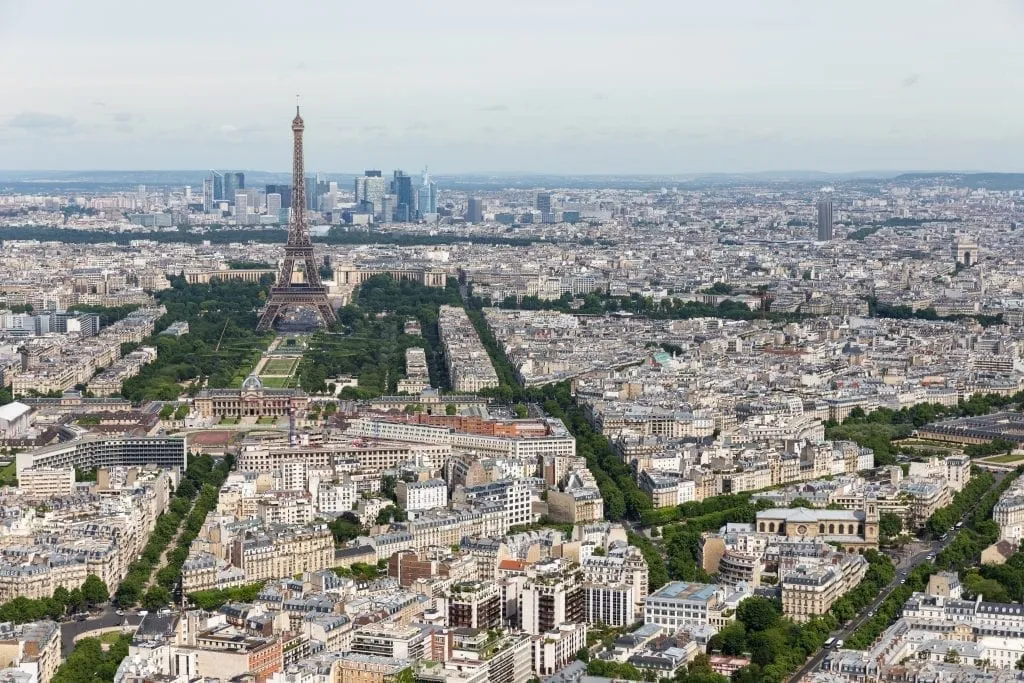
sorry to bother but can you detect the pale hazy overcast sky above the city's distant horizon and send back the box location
[0,0,1024,173]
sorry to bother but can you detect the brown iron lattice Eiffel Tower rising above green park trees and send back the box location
[256,104,337,332]
